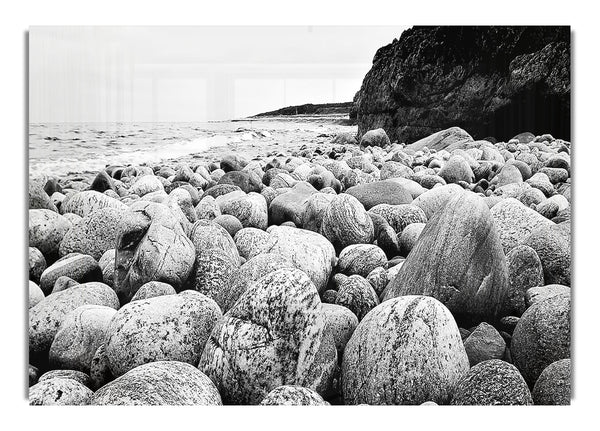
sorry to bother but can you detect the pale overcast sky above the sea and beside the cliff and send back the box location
[29,26,407,123]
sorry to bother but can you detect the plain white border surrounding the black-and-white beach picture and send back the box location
[0,0,600,430]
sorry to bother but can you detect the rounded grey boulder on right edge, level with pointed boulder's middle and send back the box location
[523,222,571,286]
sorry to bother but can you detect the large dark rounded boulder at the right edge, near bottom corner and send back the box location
[510,293,571,385]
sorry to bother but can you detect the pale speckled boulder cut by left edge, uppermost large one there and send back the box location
[29,209,72,257]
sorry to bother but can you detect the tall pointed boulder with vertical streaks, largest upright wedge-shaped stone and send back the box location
[382,192,508,322]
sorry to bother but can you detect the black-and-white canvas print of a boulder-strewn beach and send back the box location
[28,25,573,406]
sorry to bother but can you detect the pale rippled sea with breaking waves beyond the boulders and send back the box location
[29,117,356,177]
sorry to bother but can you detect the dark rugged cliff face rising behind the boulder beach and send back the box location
[354,26,571,143]
